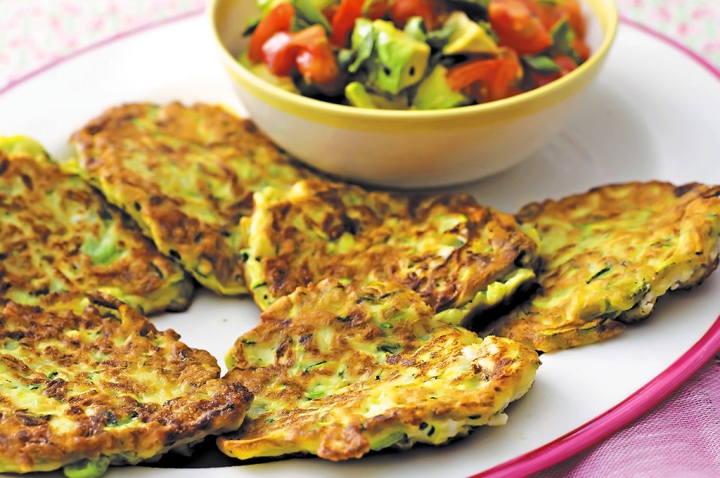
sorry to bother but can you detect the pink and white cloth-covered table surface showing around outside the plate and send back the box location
[0,0,720,478]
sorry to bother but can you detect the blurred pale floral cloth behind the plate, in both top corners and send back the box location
[0,0,720,88]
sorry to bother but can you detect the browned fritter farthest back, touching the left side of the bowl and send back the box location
[69,103,309,295]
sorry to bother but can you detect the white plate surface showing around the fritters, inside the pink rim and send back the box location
[0,16,720,478]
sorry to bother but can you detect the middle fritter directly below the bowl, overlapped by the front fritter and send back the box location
[241,179,537,324]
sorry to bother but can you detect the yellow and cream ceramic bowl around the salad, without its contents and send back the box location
[208,0,618,188]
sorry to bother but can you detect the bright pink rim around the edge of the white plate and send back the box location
[0,9,720,478]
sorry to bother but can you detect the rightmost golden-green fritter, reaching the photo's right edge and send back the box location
[485,182,720,352]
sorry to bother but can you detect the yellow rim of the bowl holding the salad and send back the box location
[206,0,619,130]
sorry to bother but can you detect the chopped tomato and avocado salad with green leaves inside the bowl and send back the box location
[238,0,590,110]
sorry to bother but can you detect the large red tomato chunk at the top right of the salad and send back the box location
[488,0,552,55]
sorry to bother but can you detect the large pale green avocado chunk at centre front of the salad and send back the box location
[368,20,430,95]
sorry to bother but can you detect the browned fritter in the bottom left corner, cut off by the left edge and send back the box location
[0,293,252,478]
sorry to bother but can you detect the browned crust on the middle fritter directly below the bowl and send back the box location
[250,180,537,312]
